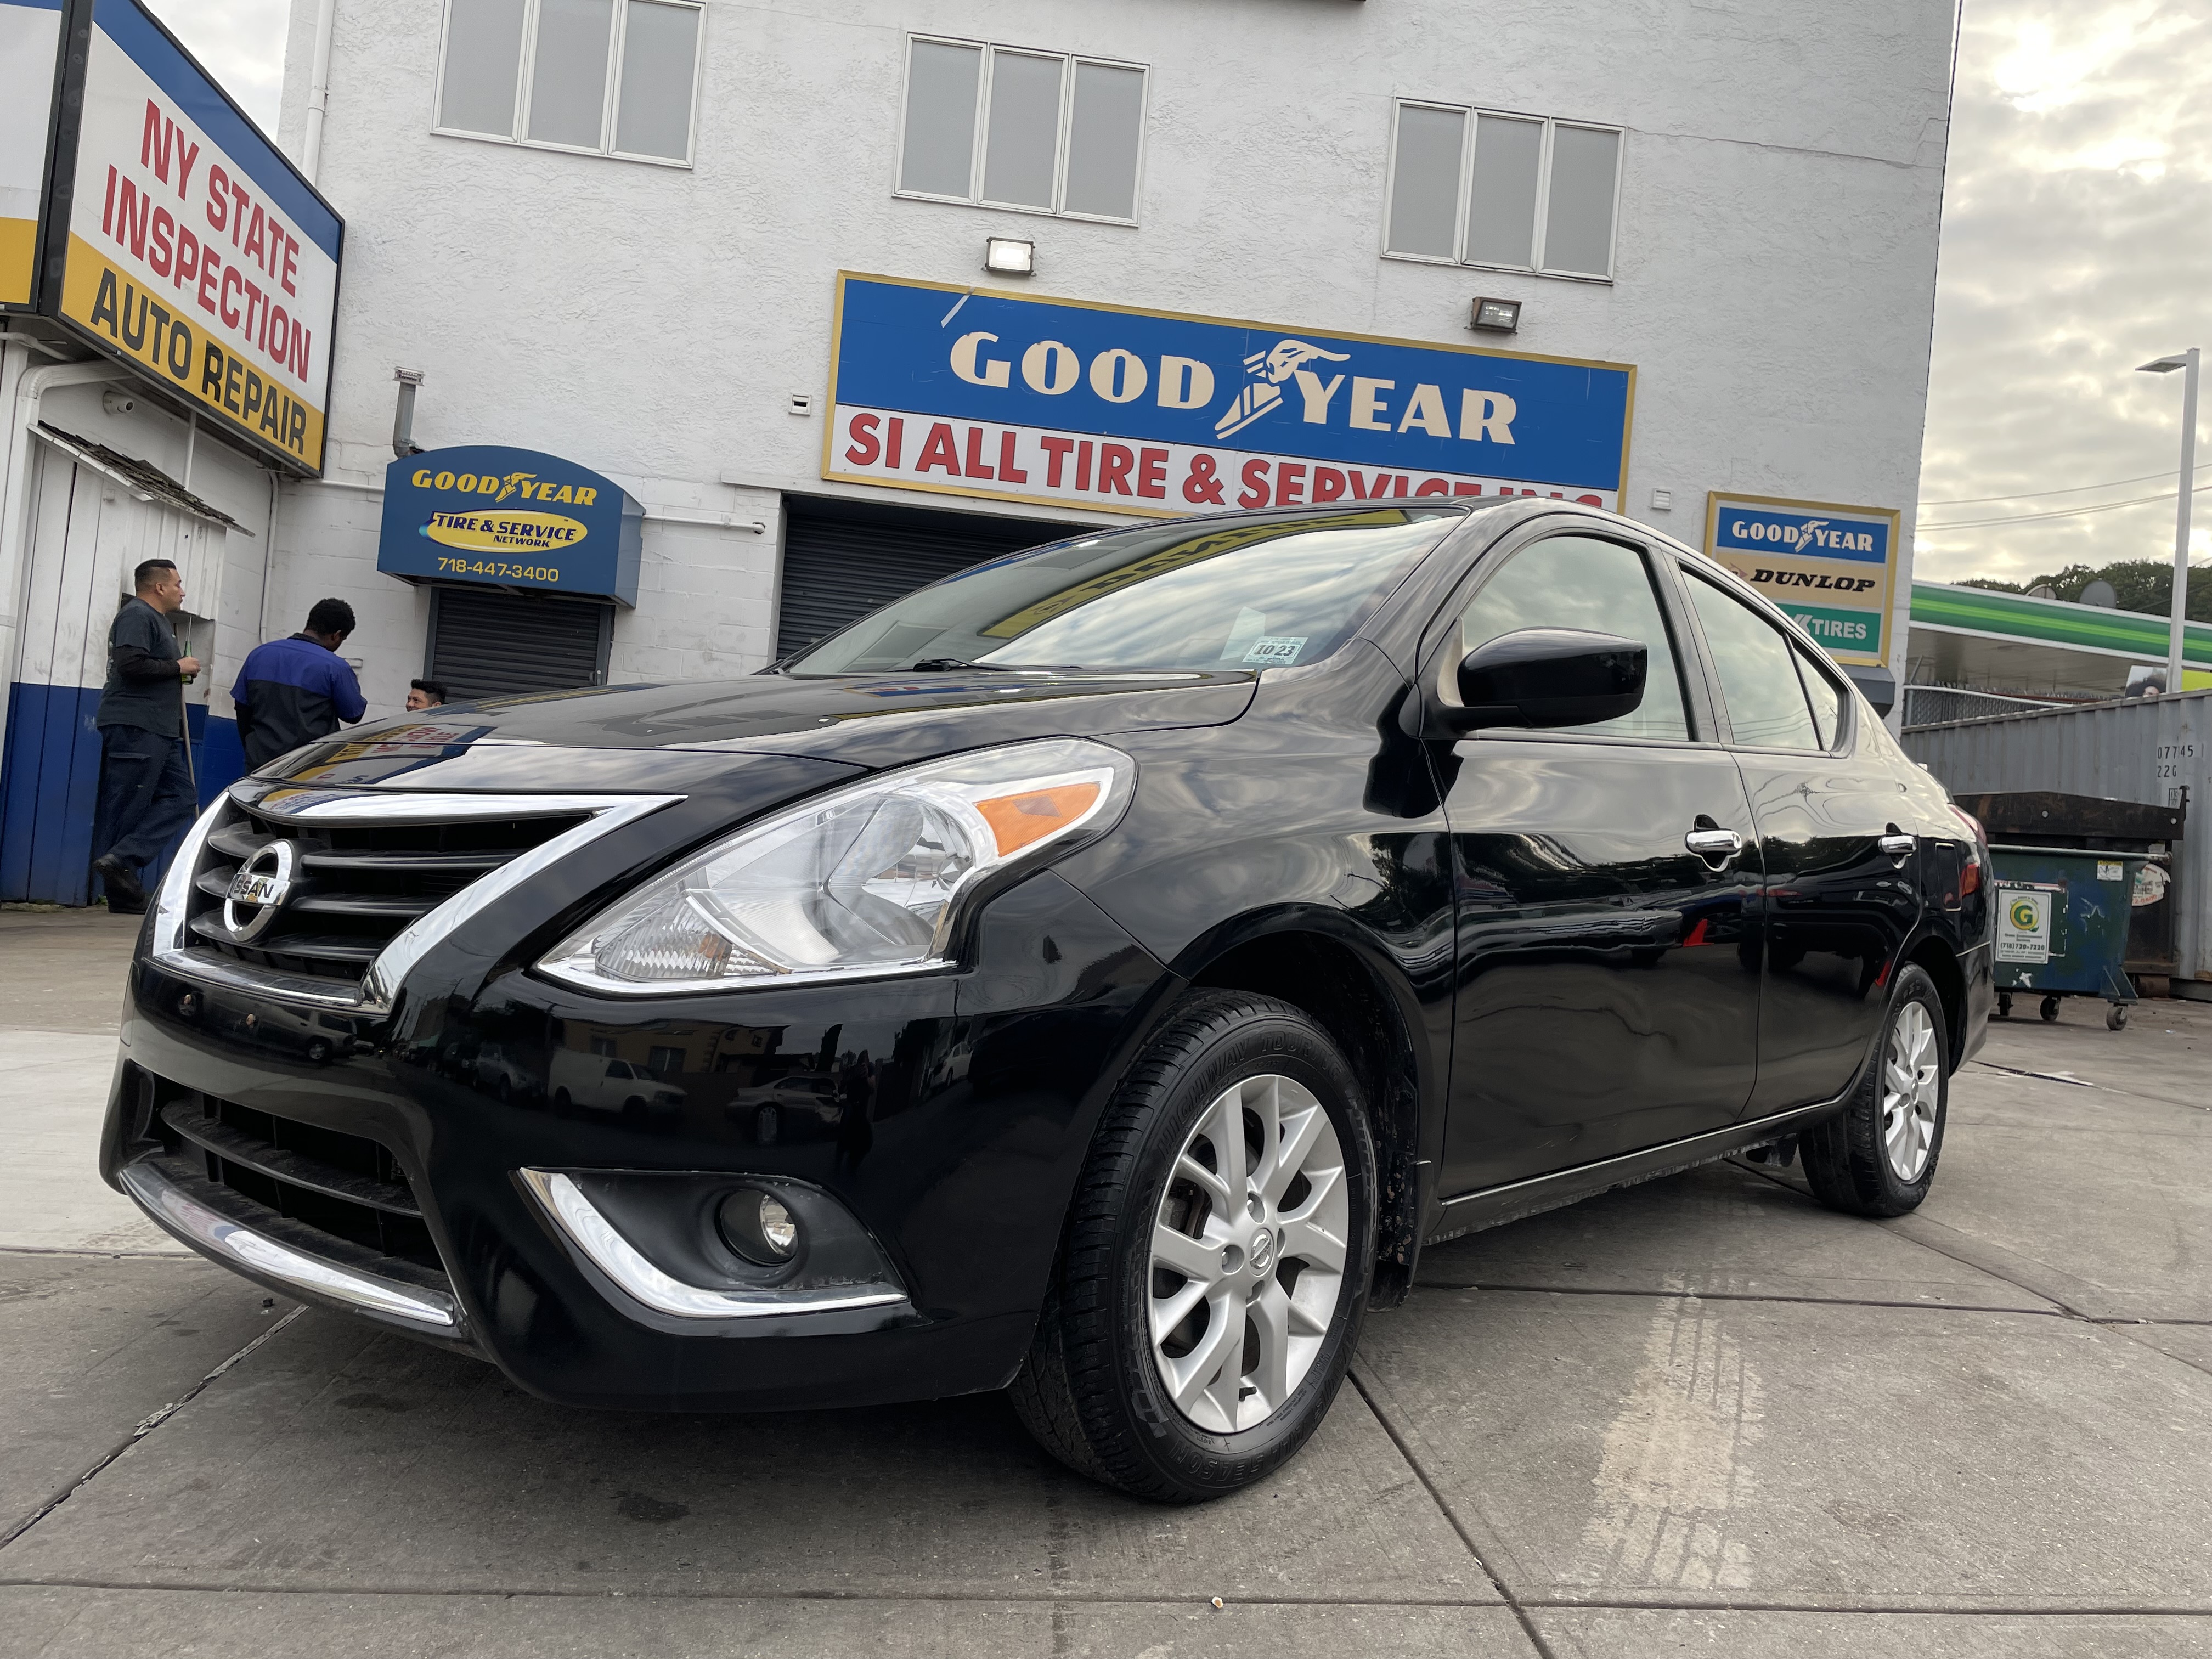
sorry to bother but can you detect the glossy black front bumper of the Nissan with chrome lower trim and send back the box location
[101,870,1177,1411]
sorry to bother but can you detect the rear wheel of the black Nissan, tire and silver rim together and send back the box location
[1798,964,1951,1217]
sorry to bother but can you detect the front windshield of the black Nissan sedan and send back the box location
[785,506,1464,675]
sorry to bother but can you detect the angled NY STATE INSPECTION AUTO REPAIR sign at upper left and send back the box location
[40,0,345,473]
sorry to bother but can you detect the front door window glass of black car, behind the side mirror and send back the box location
[1444,535,1690,743]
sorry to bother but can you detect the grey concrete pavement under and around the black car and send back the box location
[0,911,2212,1659]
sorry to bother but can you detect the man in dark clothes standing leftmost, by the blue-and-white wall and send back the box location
[93,560,199,916]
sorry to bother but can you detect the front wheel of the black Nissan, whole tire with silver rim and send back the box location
[1009,991,1376,1504]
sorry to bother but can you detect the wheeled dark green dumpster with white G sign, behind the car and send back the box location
[1989,845,2150,1031]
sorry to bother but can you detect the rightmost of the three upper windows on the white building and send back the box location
[1383,104,1621,281]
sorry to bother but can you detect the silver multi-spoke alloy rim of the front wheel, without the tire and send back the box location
[1150,1075,1352,1434]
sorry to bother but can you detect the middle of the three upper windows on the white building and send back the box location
[898,36,1146,223]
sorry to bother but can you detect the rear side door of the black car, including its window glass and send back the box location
[1683,571,1920,1117]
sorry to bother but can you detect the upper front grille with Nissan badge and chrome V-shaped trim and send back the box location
[153,778,681,1013]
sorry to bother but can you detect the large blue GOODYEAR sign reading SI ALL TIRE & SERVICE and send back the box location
[823,272,1635,515]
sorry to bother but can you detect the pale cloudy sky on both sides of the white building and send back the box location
[148,0,2212,579]
